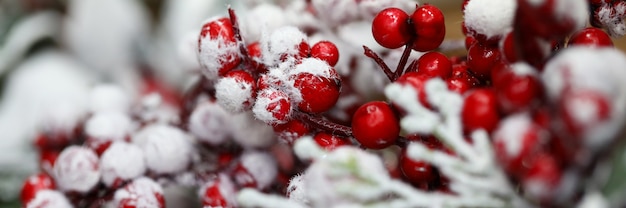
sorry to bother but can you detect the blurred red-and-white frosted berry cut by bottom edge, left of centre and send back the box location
[199,174,237,207]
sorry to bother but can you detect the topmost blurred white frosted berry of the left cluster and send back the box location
[89,84,131,112]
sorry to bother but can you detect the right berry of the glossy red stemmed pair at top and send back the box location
[411,4,446,52]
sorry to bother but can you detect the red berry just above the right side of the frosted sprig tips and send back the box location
[461,88,499,132]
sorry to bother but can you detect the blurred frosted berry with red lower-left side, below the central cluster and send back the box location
[232,151,278,189]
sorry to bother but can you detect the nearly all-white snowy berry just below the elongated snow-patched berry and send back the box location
[215,77,254,113]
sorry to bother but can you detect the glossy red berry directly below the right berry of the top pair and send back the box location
[410,52,452,79]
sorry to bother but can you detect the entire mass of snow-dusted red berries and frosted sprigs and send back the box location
[21,0,626,207]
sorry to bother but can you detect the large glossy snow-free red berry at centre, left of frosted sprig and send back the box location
[352,101,400,149]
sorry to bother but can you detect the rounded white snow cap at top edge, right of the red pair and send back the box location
[464,0,517,38]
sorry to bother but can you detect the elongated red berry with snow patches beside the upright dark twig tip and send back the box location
[198,17,241,80]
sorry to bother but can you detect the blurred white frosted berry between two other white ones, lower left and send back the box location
[100,142,146,187]
